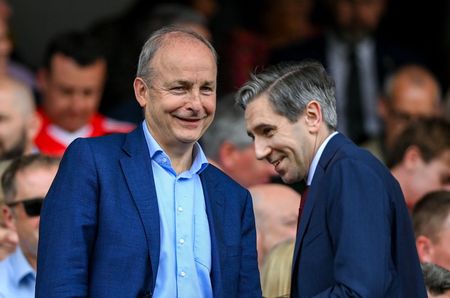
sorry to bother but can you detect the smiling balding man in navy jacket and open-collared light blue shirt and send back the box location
[36,28,261,298]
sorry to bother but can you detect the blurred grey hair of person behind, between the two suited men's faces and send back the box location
[202,94,252,159]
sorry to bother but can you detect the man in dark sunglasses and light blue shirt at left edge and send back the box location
[0,154,59,298]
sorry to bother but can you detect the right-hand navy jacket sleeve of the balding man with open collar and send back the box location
[238,191,262,298]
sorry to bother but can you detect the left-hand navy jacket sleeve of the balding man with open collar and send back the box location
[36,139,98,298]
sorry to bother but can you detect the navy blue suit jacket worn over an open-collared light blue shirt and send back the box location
[36,127,261,298]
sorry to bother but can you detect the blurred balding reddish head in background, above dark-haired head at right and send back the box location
[379,65,441,148]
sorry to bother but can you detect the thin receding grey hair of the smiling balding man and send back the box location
[136,26,217,82]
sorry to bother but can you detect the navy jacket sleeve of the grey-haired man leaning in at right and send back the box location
[315,160,394,298]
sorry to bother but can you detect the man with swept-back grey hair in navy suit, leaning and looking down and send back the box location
[238,62,426,297]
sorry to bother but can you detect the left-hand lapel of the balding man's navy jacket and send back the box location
[120,126,160,286]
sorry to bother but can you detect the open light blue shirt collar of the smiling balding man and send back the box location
[142,120,209,175]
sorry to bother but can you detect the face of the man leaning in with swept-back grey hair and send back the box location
[245,95,313,183]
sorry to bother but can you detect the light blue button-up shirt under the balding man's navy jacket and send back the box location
[142,121,212,298]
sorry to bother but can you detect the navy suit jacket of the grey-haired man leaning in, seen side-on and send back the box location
[291,134,427,298]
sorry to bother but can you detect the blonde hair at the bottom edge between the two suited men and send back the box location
[261,239,295,298]
